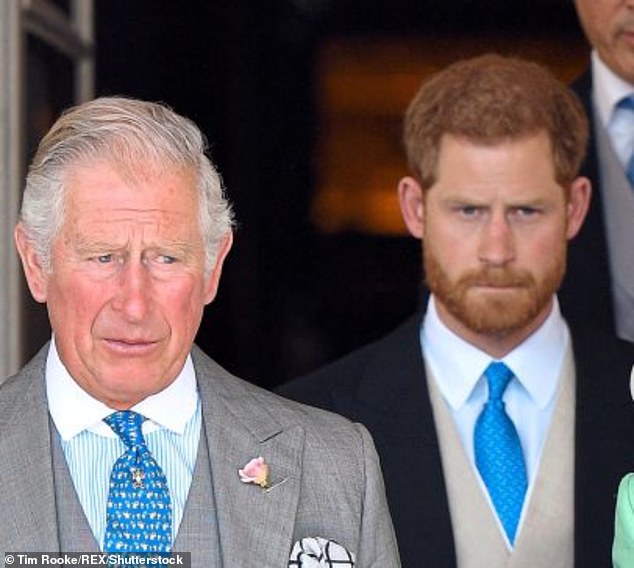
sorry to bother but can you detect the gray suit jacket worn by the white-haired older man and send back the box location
[0,347,400,568]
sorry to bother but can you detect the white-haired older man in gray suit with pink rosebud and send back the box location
[0,98,399,568]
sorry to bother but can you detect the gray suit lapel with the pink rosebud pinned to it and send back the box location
[194,350,304,568]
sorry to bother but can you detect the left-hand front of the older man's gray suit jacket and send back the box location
[0,348,59,551]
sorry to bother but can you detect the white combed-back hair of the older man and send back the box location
[20,97,233,272]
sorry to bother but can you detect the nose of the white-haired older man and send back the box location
[113,260,152,323]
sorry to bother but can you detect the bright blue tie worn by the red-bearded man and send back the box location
[473,363,527,544]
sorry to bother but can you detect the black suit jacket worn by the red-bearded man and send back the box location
[279,317,634,568]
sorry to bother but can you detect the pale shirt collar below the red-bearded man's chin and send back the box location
[421,295,570,409]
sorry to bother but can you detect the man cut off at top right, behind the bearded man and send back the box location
[561,0,634,343]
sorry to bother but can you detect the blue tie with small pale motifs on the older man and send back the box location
[104,410,172,553]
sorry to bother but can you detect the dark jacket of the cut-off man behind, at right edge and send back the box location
[559,70,614,333]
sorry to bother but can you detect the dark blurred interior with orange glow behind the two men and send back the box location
[0,0,589,387]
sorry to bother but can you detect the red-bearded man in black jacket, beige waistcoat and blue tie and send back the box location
[280,55,634,568]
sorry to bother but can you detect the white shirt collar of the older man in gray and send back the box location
[46,337,198,440]
